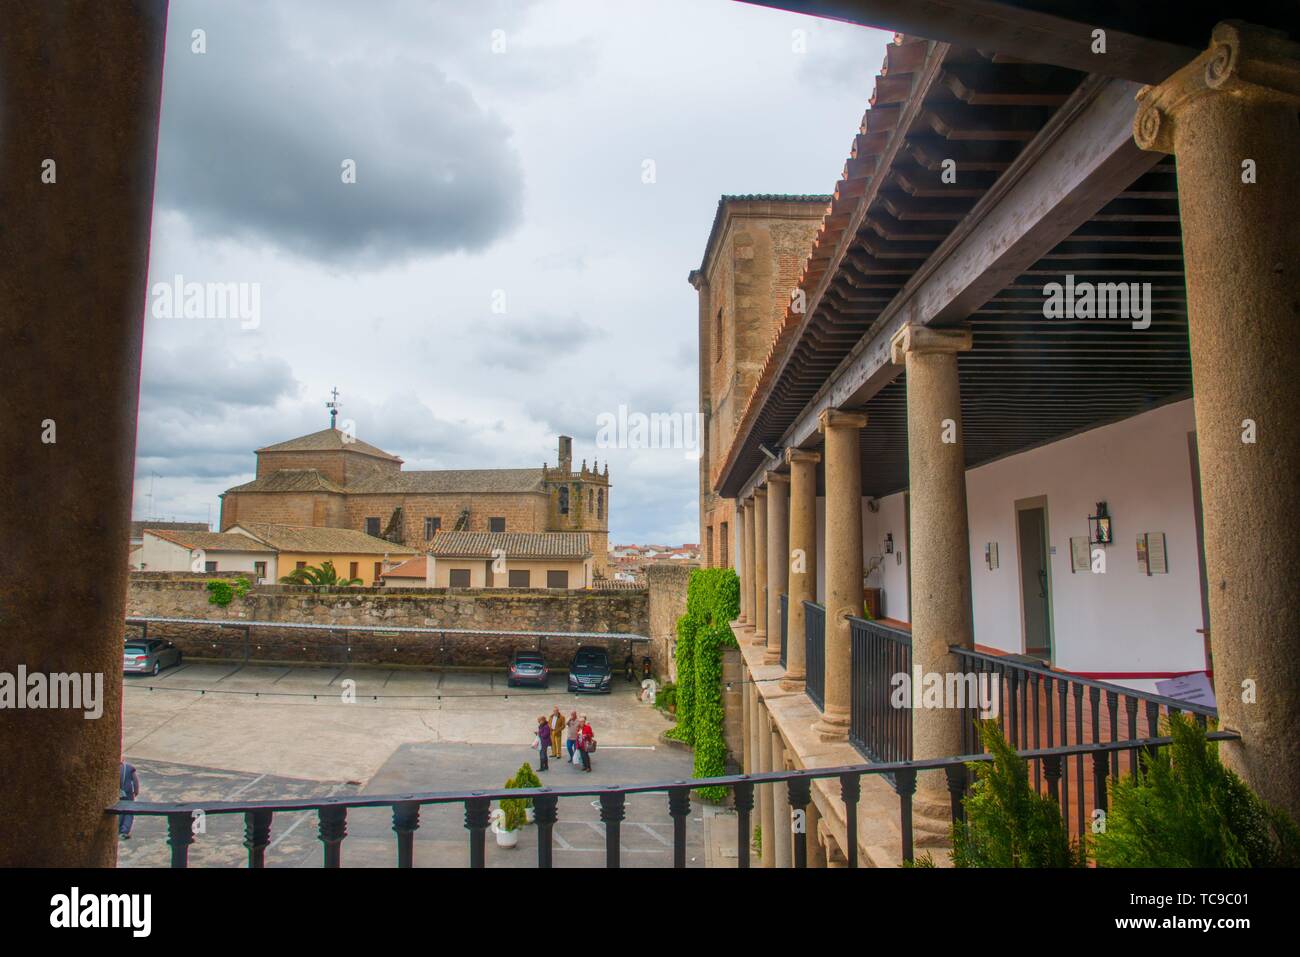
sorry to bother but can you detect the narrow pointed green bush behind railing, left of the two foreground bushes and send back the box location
[952,720,1087,867]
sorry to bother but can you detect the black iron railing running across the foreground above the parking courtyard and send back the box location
[107,731,1238,869]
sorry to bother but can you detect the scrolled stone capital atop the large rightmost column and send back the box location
[1134,20,1300,153]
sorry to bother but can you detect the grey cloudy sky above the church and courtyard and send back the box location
[134,0,888,544]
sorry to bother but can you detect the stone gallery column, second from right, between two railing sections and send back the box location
[889,325,972,817]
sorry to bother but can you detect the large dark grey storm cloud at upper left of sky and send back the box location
[157,0,523,268]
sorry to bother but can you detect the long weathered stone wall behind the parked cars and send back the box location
[126,572,649,671]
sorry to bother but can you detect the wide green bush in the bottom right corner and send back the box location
[1093,715,1300,867]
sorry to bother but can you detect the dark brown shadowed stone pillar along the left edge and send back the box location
[0,0,166,867]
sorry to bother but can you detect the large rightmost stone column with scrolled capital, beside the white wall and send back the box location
[1132,23,1300,818]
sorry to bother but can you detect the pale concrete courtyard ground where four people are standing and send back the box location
[120,662,735,867]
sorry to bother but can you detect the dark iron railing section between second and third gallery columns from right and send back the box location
[849,618,909,761]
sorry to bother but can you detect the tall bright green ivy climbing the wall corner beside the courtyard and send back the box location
[667,568,740,801]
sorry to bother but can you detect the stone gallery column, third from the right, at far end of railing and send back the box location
[813,408,867,741]
